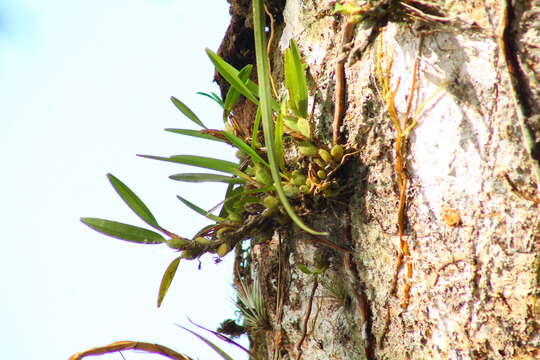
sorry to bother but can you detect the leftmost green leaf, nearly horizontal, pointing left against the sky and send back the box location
[81,218,165,244]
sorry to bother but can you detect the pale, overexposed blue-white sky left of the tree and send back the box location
[0,0,251,360]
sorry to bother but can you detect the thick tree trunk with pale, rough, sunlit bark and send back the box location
[222,0,540,360]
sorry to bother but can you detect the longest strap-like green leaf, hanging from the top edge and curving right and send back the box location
[253,0,328,235]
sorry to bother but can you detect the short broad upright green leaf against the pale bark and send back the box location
[285,39,308,118]
